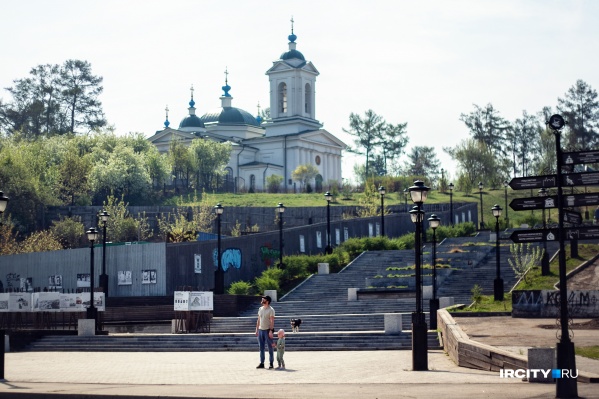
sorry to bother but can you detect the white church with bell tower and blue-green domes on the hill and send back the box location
[148,26,346,192]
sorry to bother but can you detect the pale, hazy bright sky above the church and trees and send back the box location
[0,0,599,183]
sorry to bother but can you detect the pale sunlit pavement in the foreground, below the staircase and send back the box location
[0,350,599,399]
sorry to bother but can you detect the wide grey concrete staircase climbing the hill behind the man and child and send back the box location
[27,233,551,352]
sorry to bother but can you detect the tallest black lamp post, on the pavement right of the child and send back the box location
[408,180,429,371]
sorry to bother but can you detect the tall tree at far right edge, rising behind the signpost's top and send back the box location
[557,79,599,151]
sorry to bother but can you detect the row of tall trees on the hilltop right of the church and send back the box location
[344,80,599,193]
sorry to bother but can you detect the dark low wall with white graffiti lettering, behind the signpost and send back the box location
[512,290,599,317]
